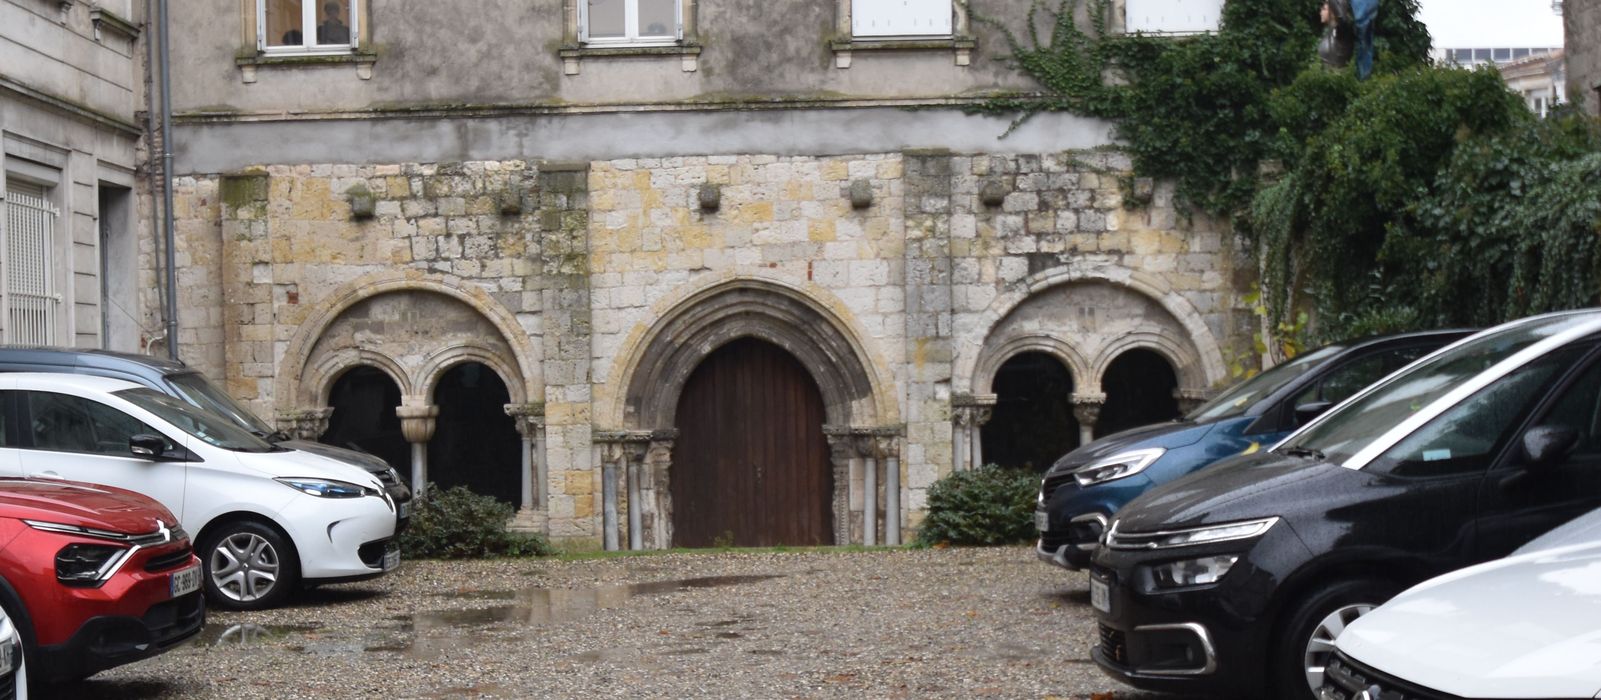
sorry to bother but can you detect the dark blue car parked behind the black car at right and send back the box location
[1034,330,1471,569]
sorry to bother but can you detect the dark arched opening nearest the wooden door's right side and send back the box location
[981,352,1079,471]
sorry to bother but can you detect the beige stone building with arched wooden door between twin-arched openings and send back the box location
[139,0,1254,548]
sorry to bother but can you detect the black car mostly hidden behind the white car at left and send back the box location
[0,346,411,527]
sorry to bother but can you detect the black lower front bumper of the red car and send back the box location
[29,591,205,681]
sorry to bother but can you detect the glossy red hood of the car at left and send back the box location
[0,479,178,535]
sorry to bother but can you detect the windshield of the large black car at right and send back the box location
[1279,314,1596,465]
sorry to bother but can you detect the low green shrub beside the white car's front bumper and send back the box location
[400,484,554,559]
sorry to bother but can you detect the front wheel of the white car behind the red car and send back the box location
[197,521,299,610]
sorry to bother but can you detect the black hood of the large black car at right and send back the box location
[1117,452,1338,532]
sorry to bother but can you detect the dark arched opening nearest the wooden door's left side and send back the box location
[427,362,522,505]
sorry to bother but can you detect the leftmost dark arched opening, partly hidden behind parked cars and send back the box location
[317,365,411,479]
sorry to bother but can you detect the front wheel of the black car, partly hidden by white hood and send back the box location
[1268,578,1396,700]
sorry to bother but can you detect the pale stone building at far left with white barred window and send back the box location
[0,0,146,351]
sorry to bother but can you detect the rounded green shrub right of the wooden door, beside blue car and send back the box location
[917,465,1039,545]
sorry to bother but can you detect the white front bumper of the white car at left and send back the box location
[279,495,399,583]
